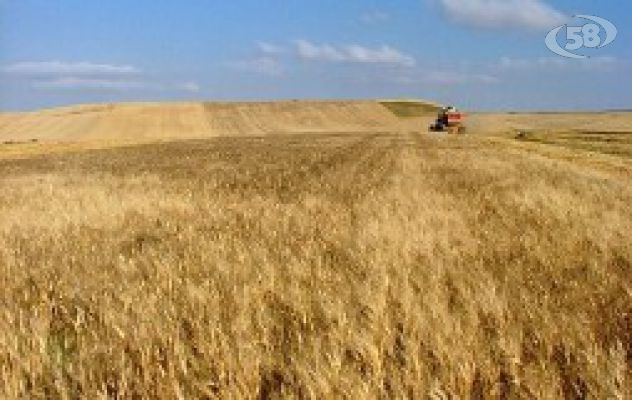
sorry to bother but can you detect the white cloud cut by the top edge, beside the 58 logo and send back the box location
[438,0,566,31]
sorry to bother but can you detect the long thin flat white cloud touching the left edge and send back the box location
[2,61,141,76]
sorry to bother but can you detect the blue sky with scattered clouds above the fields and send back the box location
[0,0,632,111]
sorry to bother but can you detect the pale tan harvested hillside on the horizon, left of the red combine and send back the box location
[0,101,434,142]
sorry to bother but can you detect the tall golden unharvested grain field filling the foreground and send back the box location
[0,128,632,399]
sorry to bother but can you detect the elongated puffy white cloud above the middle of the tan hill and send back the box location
[295,40,415,67]
